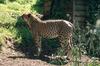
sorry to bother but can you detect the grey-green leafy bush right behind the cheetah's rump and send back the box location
[73,23,100,57]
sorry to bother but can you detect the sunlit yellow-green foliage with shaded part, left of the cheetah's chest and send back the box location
[0,0,43,50]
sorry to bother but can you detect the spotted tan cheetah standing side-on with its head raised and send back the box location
[22,13,73,59]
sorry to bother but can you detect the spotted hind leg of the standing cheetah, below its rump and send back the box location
[59,36,72,61]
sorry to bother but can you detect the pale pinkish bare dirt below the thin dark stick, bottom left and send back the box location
[0,53,55,66]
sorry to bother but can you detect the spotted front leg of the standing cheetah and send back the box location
[34,35,41,56]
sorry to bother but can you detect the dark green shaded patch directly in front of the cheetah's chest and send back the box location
[15,17,34,56]
